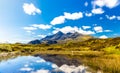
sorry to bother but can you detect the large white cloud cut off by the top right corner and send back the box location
[92,0,120,8]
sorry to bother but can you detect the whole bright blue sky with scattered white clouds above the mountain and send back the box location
[0,0,120,43]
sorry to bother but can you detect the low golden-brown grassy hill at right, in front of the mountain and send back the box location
[64,37,120,53]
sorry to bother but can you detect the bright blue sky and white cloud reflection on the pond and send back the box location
[0,56,87,73]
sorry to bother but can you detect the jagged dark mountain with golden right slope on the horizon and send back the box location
[29,31,93,44]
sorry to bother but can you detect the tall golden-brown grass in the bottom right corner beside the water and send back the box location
[84,55,120,73]
